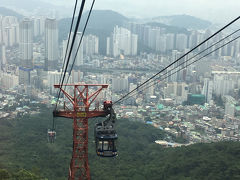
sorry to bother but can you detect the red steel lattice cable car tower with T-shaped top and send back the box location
[53,84,108,180]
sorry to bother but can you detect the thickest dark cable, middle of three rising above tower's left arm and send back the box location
[56,0,85,108]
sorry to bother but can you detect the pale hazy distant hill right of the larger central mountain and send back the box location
[152,15,211,29]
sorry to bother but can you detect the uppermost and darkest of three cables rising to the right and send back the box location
[113,16,240,105]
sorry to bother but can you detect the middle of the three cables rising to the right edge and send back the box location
[114,29,240,102]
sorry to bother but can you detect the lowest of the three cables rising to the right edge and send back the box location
[116,36,240,102]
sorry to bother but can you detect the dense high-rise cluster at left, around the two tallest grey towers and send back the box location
[0,16,99,95]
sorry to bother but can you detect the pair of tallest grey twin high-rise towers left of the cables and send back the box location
[19,18,59,85]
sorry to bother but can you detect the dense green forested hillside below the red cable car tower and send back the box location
[0,105,240,180]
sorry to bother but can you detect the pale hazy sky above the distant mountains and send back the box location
[42,0,240,22]
